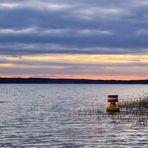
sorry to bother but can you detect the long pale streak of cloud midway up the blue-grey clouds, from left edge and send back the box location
[0,27,113,35]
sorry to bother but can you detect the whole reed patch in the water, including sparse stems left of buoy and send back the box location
[75,96,148,127]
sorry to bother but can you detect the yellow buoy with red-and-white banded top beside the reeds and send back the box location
[106,95,120,112]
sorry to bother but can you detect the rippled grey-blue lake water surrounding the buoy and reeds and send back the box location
[0,84,148,148]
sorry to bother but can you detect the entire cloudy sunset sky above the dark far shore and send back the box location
[0,0,148,80]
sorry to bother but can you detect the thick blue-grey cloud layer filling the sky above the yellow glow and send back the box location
[0,0,148,55]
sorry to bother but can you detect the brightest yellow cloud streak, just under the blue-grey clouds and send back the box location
[23,54,148,64]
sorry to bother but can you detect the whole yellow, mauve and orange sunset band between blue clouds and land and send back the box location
[0,54,148,80]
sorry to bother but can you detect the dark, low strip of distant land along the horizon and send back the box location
[0,78,148,84]
